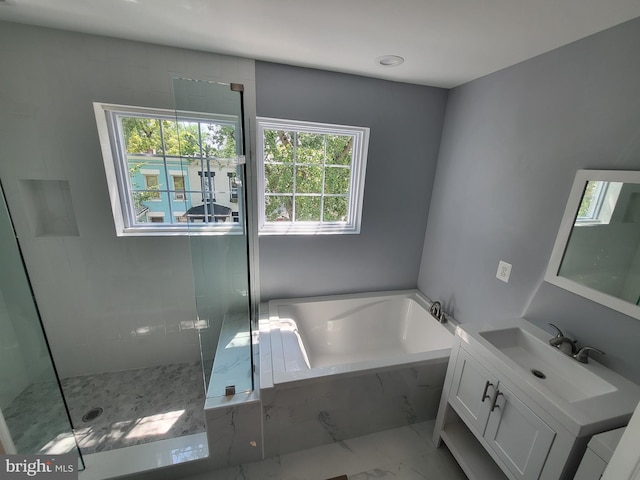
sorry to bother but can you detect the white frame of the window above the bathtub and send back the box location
[256,117,369,235]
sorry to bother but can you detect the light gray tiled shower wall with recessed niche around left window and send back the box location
[0,23,255,377]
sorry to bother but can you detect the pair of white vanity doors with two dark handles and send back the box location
[448,348,556,480]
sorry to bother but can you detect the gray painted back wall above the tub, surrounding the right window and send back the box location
[256,62,447,300]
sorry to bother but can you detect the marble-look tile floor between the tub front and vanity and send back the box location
[182,420,467,480]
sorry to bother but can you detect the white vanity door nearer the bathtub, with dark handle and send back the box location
[449,348,498,436]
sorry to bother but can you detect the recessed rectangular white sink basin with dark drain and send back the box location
[479,327,616,402]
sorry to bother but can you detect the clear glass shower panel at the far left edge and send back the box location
[0,186,83,468]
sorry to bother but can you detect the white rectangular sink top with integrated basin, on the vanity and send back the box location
[456,318,640,437]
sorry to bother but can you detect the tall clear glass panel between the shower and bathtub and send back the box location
[173,78,253,397]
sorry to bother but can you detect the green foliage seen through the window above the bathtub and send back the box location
[264,130,353,222]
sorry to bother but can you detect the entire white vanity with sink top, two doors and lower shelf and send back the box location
[433,318,640,480]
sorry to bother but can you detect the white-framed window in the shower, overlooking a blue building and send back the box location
[94,103,242,235]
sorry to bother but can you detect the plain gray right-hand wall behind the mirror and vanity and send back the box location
[418,15,640,382]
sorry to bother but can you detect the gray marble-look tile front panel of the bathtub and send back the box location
[260,358,447,456]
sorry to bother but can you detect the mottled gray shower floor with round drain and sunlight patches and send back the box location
[7,362,205,455]
